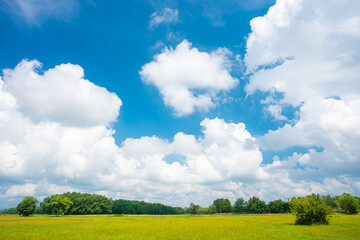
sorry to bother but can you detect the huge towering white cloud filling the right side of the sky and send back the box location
[244,0,360,188]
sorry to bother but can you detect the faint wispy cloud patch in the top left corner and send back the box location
[0,0,79,26]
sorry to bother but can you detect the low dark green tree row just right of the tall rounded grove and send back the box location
[112,199,184,215]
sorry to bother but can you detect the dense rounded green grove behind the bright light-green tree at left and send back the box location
[41,192,113,215]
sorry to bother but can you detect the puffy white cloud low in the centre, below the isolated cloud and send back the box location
[118,118,267,183]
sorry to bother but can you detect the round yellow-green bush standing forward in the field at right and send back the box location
[290,194,332,225]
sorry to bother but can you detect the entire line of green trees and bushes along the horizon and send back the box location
[0,192,360,224]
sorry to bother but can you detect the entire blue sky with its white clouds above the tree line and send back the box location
[0,0,360,208]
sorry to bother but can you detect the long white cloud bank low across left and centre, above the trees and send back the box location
[0,113,268,205]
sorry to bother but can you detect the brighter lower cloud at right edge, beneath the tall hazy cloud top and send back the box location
[259,96,360,177]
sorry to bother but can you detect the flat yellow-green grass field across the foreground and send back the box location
[0,214,360,240]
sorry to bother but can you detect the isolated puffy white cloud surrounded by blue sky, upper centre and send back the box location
[140,40,238,116]
